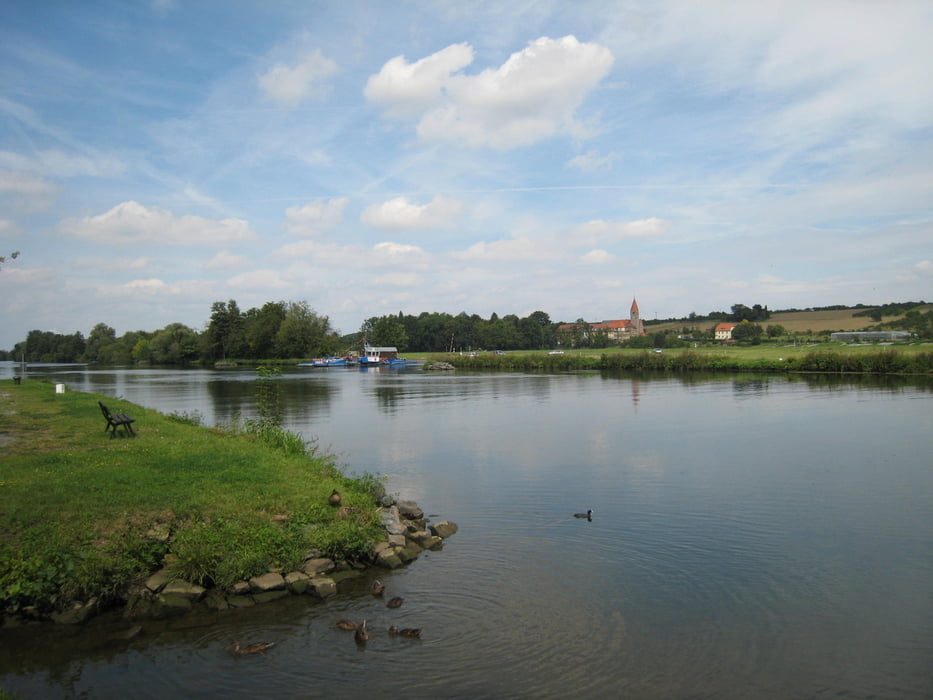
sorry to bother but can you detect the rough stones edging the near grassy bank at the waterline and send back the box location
[13,501,457,625]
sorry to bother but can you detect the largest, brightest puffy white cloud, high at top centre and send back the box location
[365,36,613,150]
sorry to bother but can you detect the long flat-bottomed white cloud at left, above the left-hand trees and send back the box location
[59,201,254,245]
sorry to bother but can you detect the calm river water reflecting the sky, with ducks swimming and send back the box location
[0,365,933,698]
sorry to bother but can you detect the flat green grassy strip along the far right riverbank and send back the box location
[431,344,933,374]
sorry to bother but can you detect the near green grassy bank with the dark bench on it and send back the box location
[0,379,380,612]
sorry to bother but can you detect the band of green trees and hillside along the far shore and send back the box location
[0,299,933,366]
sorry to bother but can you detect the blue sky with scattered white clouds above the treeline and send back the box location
[0,0,933,349]
